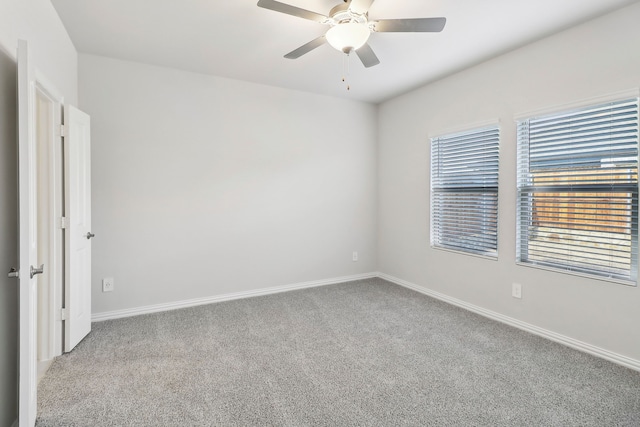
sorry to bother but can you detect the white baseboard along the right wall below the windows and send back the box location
[378,273,640,371]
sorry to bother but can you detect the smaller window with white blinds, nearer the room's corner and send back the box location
[431,126,500,257]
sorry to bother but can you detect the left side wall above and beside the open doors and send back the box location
[0,0,77,426]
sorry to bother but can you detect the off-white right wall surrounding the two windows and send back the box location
[378,4,640,360]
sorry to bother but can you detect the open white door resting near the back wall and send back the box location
[64,106,93,351]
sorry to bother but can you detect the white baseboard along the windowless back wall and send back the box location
[91,273,378,322]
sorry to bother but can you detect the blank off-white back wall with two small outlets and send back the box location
[79,55,377,314]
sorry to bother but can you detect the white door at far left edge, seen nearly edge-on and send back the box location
[18,40,42,427]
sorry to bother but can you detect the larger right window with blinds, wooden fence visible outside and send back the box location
[516,99,638,282]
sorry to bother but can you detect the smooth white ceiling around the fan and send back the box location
[52,0,638,103]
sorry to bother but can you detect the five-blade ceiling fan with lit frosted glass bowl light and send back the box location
[258,0,447,68]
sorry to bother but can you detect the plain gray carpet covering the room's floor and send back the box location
[37,279,640,427]
